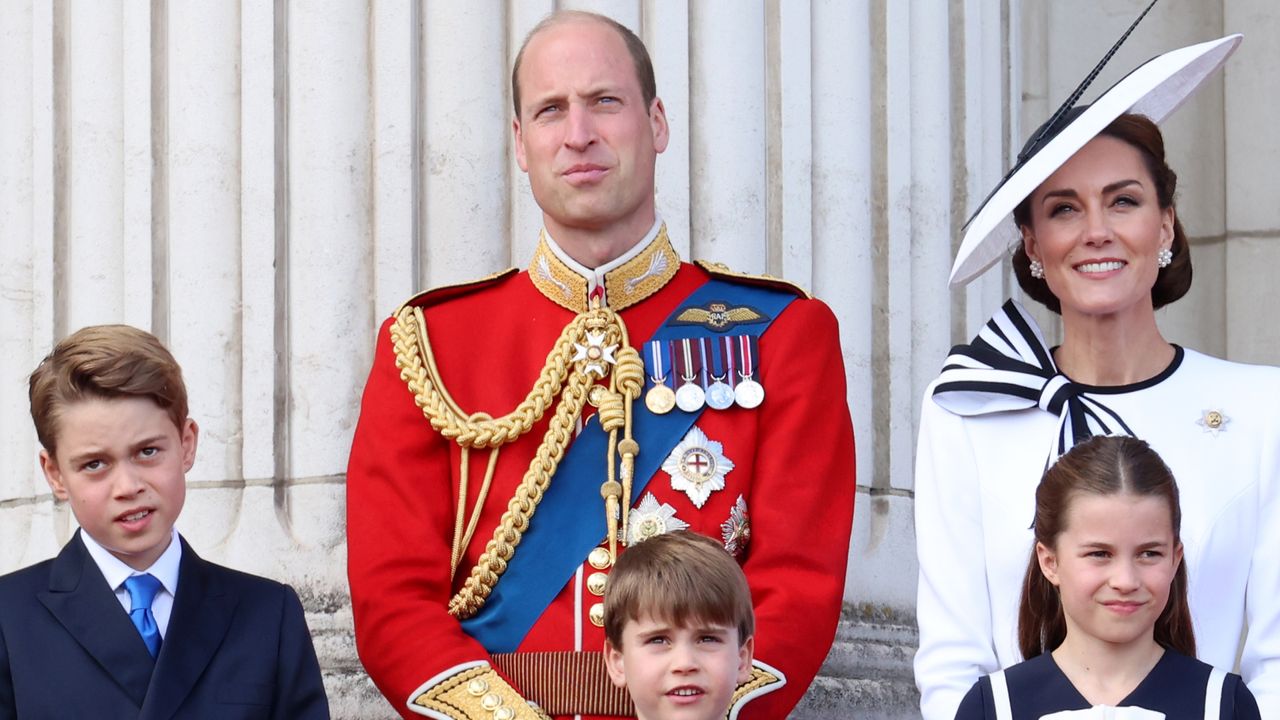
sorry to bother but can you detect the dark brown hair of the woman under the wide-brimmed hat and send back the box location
[1014,113,1192,313]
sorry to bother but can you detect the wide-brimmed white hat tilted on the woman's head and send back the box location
[950,32,1244,288]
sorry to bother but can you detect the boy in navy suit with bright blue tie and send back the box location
[0,325,329,720]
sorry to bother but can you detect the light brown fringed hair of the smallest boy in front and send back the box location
[604,530,755,648]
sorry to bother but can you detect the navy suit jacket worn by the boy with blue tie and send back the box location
[0,532,329,720]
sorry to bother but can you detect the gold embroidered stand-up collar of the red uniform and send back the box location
[529,223,680,313]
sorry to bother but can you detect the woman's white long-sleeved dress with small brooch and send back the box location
[915,301,1280,720]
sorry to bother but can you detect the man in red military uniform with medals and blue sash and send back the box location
[347,12,855,720]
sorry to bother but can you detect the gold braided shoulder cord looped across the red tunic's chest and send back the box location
[390,298,644,619]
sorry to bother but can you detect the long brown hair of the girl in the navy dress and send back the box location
[1018,436,1196,660]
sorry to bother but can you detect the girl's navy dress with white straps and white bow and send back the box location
[955,651,1262,720]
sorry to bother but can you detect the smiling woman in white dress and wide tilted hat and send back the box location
[915,30,1280,720]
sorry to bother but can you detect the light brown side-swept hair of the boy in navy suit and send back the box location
[28,325,187,455]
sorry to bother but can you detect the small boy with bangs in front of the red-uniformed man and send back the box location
[604,530,781,720]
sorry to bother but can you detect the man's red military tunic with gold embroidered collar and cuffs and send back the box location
[347,225,855,719]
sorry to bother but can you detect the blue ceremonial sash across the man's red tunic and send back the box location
[462,279,796,653]
